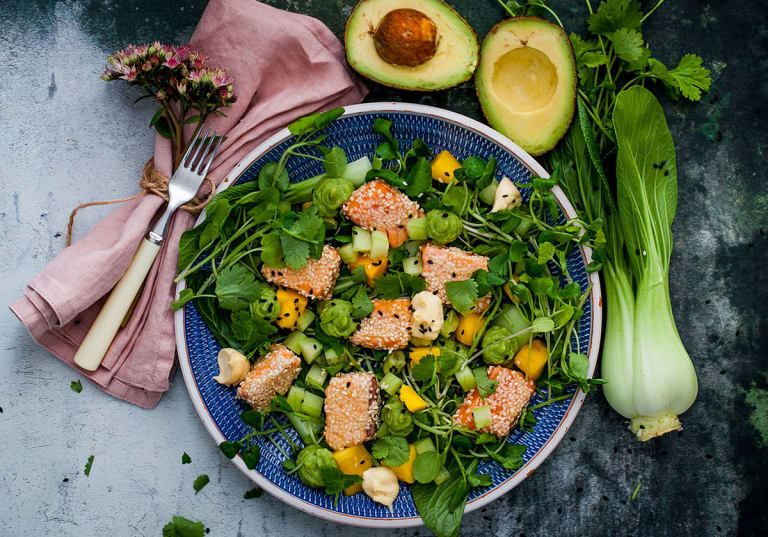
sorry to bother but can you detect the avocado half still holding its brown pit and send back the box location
[344,0,479,91]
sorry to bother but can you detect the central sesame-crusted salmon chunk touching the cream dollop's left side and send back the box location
[349,298,411,351]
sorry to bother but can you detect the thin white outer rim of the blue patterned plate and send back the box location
[174,102,603,528]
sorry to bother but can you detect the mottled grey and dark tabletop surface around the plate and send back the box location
[0,0,768,537]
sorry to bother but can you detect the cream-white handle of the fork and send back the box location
[75,239,160,371]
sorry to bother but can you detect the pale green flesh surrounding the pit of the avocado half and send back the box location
[344,0,479,91]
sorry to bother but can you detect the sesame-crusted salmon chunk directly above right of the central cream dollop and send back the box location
[421,243,491,312]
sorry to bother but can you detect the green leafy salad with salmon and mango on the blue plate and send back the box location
[173,105,601,536]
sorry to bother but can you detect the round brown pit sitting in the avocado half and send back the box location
[373,8,437,67]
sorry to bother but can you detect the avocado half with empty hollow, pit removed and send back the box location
[475,17,576,155]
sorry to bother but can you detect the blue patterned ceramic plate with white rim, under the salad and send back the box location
[175,103,602,528]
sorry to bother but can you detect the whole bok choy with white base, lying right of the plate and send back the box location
[602,86,698,440]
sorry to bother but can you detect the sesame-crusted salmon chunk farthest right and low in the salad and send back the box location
[453,365,536,437]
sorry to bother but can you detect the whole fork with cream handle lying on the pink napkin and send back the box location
[75,128,223,371]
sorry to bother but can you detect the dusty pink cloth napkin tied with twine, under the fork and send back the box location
[10,0,366,408]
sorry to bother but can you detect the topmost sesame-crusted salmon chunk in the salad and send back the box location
[341,179,424,248]
